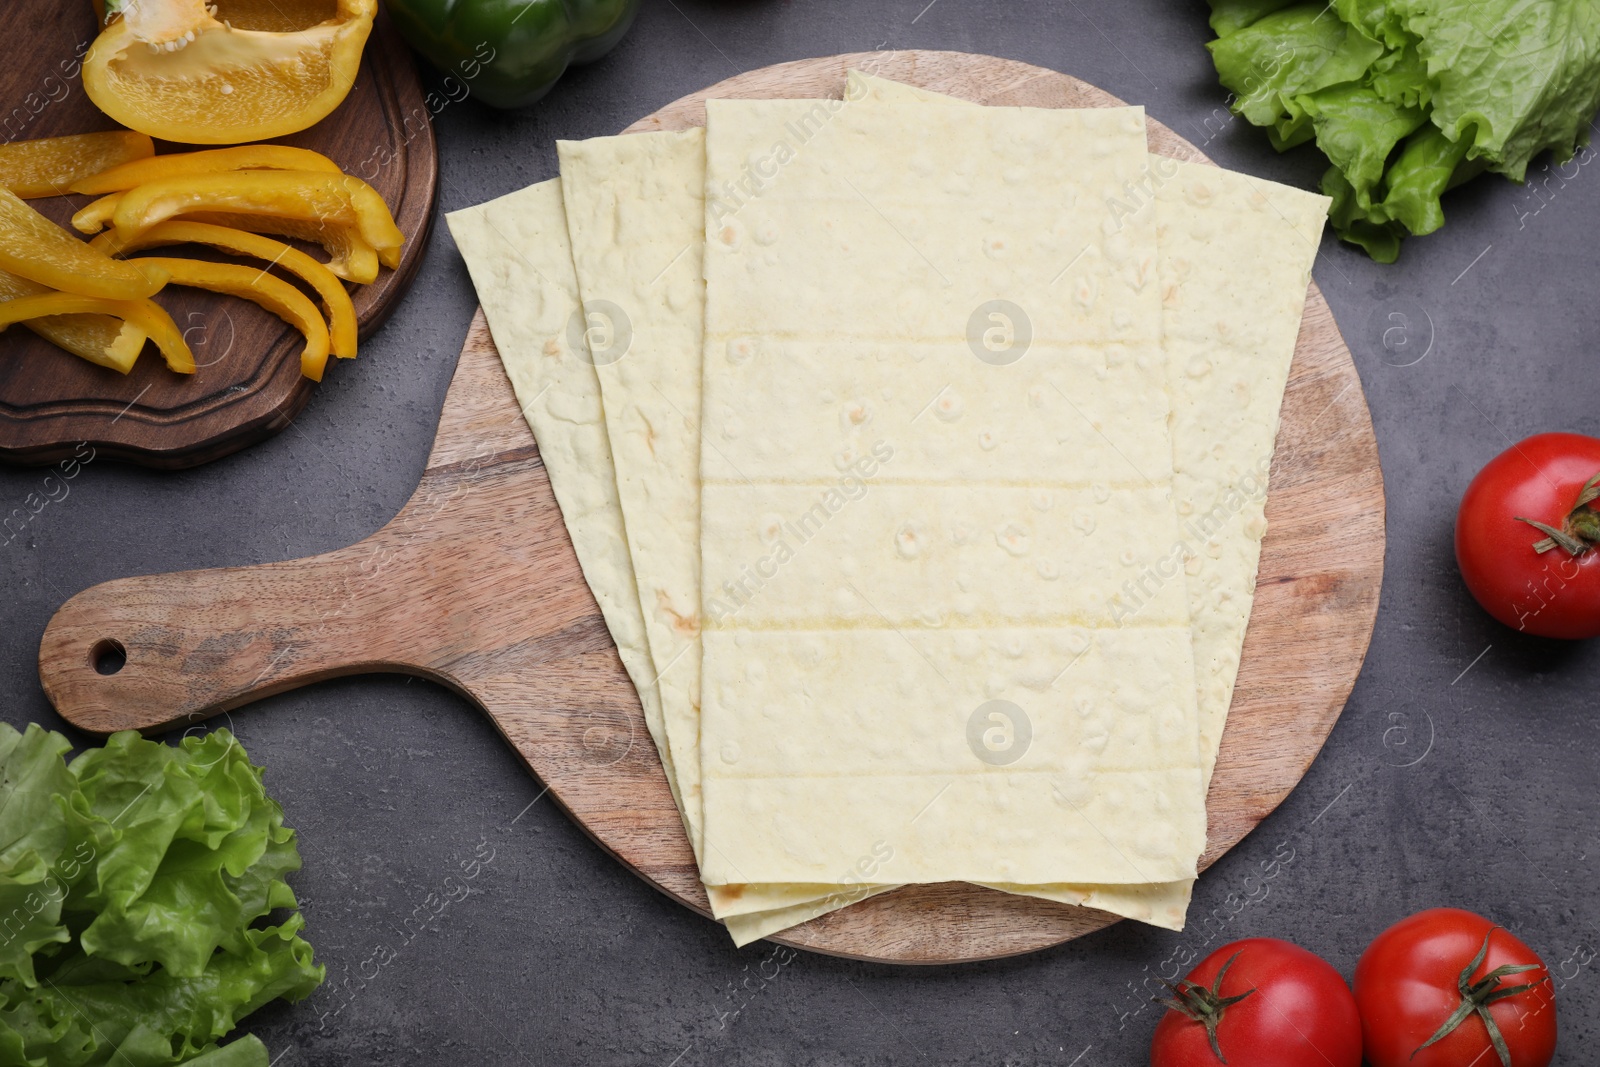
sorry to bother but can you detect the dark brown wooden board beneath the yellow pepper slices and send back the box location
[0,0,438,469]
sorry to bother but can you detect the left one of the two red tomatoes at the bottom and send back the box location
[1150,937,1362,1067]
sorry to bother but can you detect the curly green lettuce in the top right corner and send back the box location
[1208,0,1600,255]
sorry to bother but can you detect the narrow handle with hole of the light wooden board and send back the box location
[38,541,432,733]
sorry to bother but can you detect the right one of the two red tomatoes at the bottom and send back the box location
[1355,907,1555,1067]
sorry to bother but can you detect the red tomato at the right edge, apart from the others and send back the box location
[1456,434,1600,638]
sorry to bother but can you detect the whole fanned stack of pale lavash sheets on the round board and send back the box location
[450,74,1328,944]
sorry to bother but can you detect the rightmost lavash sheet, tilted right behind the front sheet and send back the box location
[846,70,1328,928]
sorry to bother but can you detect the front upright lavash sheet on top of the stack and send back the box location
[701,101,1205,885]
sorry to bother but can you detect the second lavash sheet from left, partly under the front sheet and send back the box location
[555,130,706,857]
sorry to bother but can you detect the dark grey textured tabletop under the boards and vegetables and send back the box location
[0,0,1600,1067]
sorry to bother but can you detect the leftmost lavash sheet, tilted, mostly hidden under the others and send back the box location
[446,179,683,811]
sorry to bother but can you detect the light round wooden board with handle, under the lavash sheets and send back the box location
[40,53,1384,963]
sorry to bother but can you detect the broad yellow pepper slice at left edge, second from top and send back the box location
[0,189,166,301]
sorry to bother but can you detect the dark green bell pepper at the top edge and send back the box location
[386,0,638,107]
